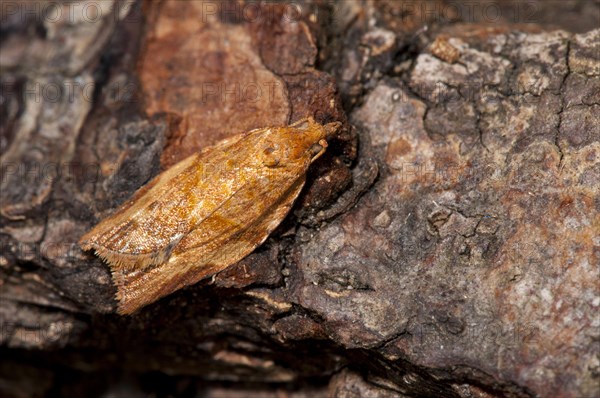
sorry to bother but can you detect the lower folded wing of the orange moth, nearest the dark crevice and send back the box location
[113,174,304,314]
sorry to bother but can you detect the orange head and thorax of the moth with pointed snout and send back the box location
[261,118,341,167]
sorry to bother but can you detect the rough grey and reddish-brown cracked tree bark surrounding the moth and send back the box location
[0,1,600,397]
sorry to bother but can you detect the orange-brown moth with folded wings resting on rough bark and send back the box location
[79,117,340,314]
